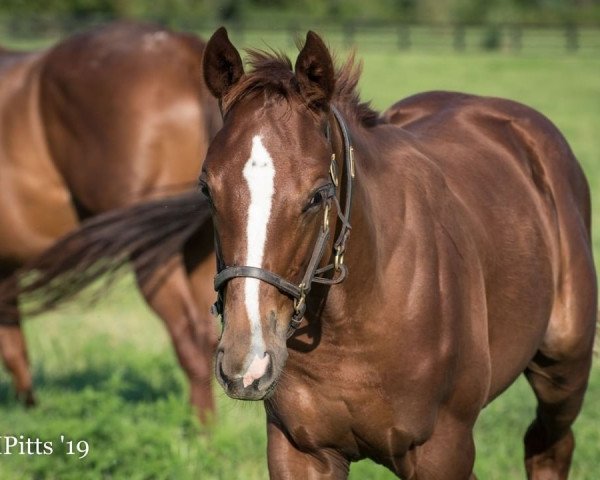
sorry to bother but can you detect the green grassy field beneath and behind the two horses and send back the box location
[0,43,600,480]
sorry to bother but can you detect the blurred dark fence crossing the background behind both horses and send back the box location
[0,17,600,55]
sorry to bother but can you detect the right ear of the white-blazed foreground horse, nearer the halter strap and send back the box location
[295,31,335,106]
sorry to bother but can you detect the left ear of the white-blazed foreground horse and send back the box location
[203,27,244,99]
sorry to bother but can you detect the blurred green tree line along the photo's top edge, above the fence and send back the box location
[0,0,600,24]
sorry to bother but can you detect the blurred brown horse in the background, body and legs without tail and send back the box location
[0,23,221,420]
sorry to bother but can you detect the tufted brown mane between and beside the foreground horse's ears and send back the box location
[222,45,379,127]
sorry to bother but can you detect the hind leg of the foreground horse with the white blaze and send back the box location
[525,256,596,480]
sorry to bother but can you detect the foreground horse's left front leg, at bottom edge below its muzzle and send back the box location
[267,421,350,480]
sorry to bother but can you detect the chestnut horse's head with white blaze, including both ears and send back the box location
[201,29,342,400]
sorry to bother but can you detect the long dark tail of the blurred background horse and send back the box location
[0,192,211,315]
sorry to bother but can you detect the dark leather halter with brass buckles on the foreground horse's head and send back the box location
[213,105,355,338]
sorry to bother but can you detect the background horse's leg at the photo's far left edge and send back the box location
[0,272,35,406]
